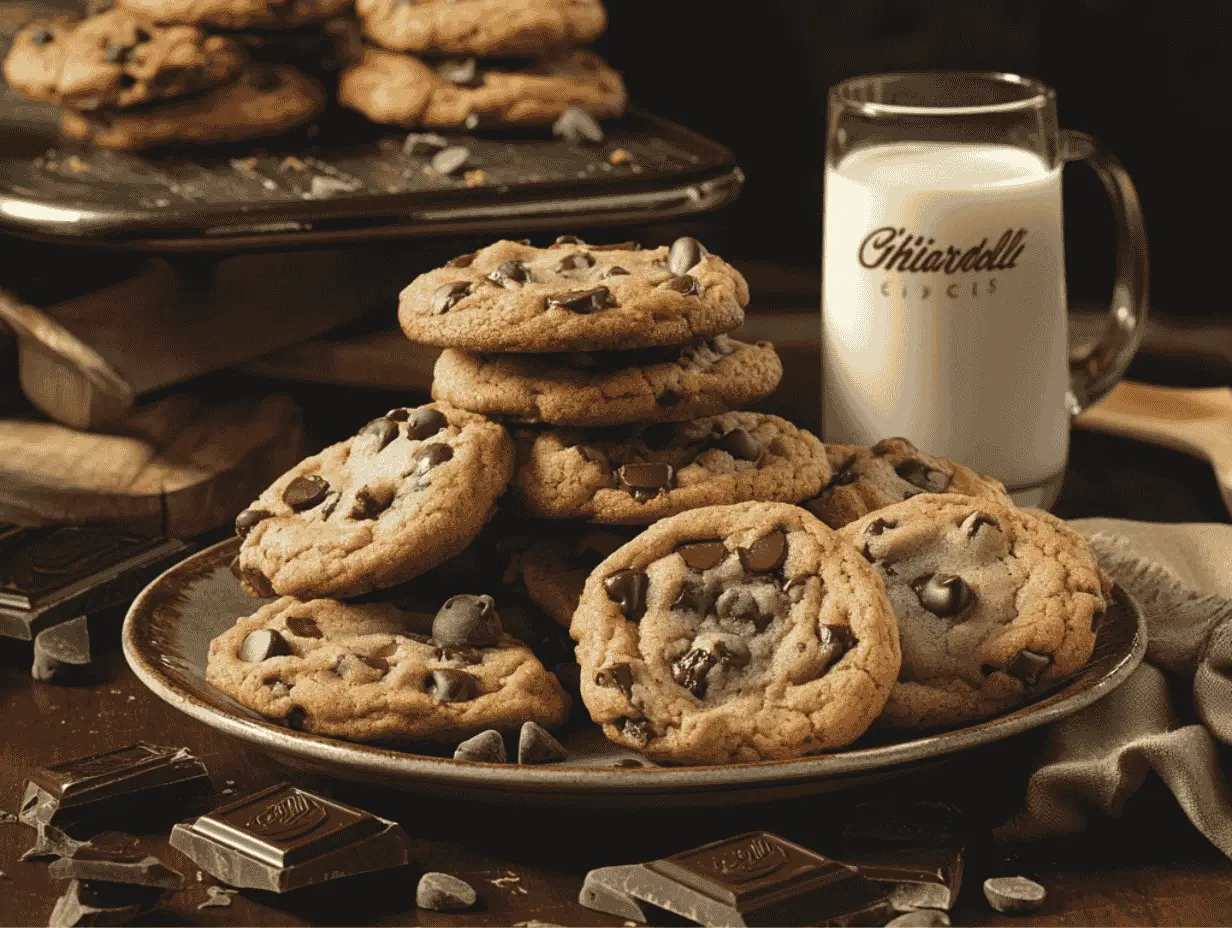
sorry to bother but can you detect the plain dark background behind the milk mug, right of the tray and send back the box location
[599,0,1232,315]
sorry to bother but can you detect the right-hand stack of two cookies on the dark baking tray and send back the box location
[339,0,627,131]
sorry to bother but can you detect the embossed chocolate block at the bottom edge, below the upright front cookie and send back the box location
[578,832,893,926]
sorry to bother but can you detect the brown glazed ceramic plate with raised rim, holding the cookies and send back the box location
[123,539,1146,806]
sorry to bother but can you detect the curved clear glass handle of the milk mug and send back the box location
[1061,129,1149,415]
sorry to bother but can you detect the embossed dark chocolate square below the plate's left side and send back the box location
[171,783,410,892]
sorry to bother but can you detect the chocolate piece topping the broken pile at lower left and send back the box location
[18,742,214,828]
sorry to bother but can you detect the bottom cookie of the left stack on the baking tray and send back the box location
[60,65,325,150]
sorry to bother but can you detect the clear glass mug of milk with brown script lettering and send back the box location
[822,71,1147,508]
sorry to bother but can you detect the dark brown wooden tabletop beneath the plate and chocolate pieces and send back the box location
[0,350,1232,926]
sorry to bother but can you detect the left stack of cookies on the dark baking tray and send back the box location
[4,0,350,149]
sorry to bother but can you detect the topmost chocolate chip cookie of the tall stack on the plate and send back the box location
[398,235,749,354]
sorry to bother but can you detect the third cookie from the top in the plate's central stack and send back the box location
[514,413,829,525]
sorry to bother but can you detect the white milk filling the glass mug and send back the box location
[822,143,1069,488]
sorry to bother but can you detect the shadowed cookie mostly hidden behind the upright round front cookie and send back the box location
[515,524,637,629]
